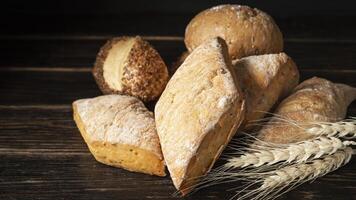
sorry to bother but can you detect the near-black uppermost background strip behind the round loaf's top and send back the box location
[0,0,356,37]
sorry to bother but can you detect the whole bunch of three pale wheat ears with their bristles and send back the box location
[186,118,356,199]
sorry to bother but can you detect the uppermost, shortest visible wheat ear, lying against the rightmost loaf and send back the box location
[306,118,356,138]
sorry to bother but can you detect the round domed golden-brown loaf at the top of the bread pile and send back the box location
[184,5,283,59]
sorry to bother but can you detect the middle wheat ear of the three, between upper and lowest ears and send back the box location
[225,136,356,169]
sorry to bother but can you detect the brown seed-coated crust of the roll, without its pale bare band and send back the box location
[93,36,169,101]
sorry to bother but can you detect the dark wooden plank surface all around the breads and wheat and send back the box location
[0,12,356,200]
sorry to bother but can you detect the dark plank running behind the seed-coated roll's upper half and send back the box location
[0,39,356,70]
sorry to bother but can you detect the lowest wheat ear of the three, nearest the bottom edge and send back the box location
[238,147,353,200]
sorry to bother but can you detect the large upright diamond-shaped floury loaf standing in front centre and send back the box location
[155,38,245,194]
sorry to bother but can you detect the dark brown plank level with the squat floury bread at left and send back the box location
[0,102,356,153]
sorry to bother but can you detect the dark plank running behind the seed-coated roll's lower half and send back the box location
[0,70,356,106]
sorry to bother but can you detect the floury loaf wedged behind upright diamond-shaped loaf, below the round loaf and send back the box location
[233,53,299,128]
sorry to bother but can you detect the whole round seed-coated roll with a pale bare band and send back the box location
[93,36,168,101]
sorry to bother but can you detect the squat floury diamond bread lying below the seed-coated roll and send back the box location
[73,95,165,176]
